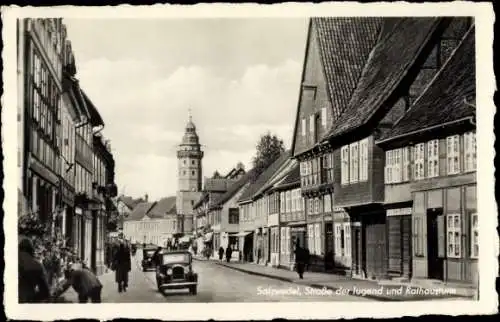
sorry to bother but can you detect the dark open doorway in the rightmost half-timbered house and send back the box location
[427,208,444,280]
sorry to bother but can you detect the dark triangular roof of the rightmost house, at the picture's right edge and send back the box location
[382,27,476,140]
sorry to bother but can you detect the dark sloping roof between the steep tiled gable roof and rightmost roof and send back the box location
[327,17,441,138]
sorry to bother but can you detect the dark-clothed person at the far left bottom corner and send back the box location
[18,238,50,303]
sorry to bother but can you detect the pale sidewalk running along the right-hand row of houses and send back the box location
[210,258,475,301]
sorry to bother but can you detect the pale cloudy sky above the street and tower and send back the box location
[65,19,307,200]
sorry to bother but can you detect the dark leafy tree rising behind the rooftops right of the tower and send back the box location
[252,131,285,180]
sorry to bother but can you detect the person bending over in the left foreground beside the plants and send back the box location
[53,263,102,303]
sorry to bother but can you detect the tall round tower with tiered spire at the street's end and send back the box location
[176,109,203,233]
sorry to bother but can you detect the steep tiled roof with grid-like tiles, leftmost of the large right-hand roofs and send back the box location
[312,17,383,116]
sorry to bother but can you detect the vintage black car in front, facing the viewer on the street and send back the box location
[156,250,198,295]
